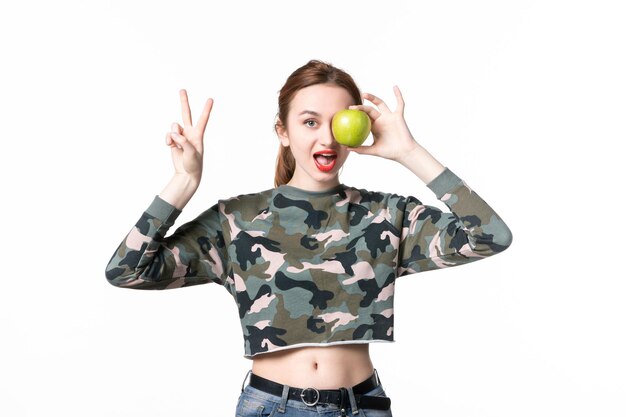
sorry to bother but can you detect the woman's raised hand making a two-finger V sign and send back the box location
[165,89,213,183]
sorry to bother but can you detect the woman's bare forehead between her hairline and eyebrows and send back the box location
[290,84,355,115]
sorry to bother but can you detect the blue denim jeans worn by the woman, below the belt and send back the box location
[237,372,392,417]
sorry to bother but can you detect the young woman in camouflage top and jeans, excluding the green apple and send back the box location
[106,61,511,417]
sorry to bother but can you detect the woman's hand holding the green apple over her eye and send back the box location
[348,86,419,161]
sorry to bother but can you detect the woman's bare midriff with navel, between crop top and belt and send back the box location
[252,343,374,389]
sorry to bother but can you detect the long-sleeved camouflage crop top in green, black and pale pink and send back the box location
[106,169,511,358]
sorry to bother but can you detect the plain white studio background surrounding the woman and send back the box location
[0,0,626,417]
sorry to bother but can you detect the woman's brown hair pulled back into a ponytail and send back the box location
[274,60,363,187]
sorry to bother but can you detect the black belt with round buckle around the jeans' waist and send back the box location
[249,373,391,410]
